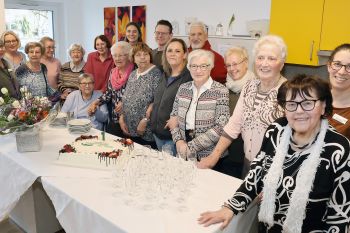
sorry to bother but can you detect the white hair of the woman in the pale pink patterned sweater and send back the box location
[253,35,287,61]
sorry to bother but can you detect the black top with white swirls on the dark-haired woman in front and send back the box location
[228,117,350,233]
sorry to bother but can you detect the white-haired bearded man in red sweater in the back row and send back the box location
[188,21,227,84]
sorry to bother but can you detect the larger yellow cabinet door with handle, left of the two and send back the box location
[270,0,324,65]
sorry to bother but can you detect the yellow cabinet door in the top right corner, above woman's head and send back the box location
[320,0,350,50]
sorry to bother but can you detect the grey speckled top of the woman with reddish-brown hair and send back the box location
[122,66,162,141]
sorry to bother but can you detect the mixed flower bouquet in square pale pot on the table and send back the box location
[0,87,51,152]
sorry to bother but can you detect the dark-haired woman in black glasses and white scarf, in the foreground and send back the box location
[199,75,350,233]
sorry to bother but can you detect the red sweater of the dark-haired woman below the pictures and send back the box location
[84,51,114,93]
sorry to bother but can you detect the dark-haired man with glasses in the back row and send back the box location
[152,19,173,71]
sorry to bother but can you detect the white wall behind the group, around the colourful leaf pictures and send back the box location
[0,0,271,62]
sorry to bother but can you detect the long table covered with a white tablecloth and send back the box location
[0,126,256,233]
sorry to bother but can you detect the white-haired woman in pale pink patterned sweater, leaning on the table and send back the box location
[198,35,287,176]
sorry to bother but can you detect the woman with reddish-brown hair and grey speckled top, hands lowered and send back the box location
[119,42,162,148]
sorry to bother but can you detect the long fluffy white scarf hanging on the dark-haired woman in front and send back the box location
[259,119,328,233]
